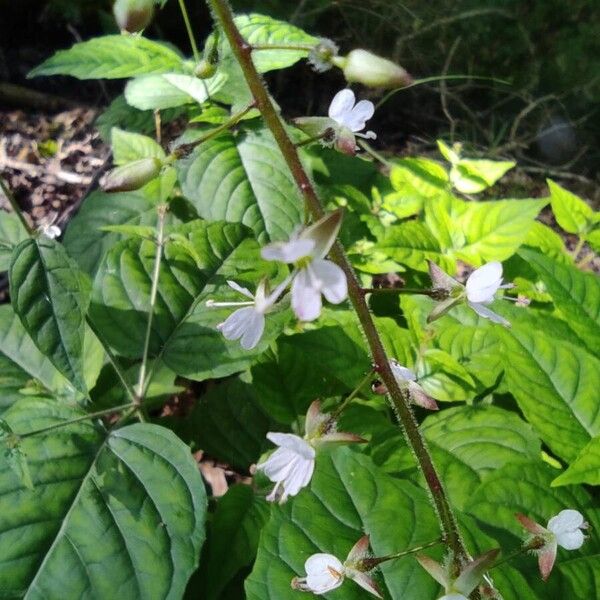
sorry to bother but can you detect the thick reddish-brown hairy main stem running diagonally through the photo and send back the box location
[207,0,468,570]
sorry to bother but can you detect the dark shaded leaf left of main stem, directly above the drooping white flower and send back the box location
[252,318,371,424]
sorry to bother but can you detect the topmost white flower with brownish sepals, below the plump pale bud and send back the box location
[294,89,377,155]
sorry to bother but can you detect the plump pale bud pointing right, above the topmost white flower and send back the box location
[332,49,413,88]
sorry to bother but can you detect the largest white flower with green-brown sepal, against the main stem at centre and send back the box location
[262,210,348,321]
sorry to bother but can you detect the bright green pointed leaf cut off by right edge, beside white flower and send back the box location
[519,248,600,355]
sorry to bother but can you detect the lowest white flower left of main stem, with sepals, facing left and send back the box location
[292,535,383,598]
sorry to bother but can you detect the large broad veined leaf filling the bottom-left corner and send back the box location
[0,398,206,600]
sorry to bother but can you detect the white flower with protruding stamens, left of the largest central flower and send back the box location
[206,279,289,350]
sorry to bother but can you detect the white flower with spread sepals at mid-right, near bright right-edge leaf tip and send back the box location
[427,261,514,327]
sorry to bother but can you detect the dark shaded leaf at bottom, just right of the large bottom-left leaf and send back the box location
[197,484,269,600]
